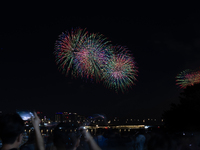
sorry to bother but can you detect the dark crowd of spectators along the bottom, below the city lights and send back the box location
[0,113,200,150]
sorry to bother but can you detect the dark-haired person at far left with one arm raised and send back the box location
[0,113,44,150]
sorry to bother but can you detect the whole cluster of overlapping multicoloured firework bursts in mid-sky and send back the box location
[54,28,138,92]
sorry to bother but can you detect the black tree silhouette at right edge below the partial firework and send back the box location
[163,84,200,131]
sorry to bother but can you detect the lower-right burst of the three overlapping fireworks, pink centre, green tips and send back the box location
[103,46,138,92]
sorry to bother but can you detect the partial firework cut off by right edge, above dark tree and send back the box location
[176,69,200,89]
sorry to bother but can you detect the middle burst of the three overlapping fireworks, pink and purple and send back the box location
[75,33,111,81]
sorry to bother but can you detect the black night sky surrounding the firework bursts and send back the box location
[0,4,200,118]
